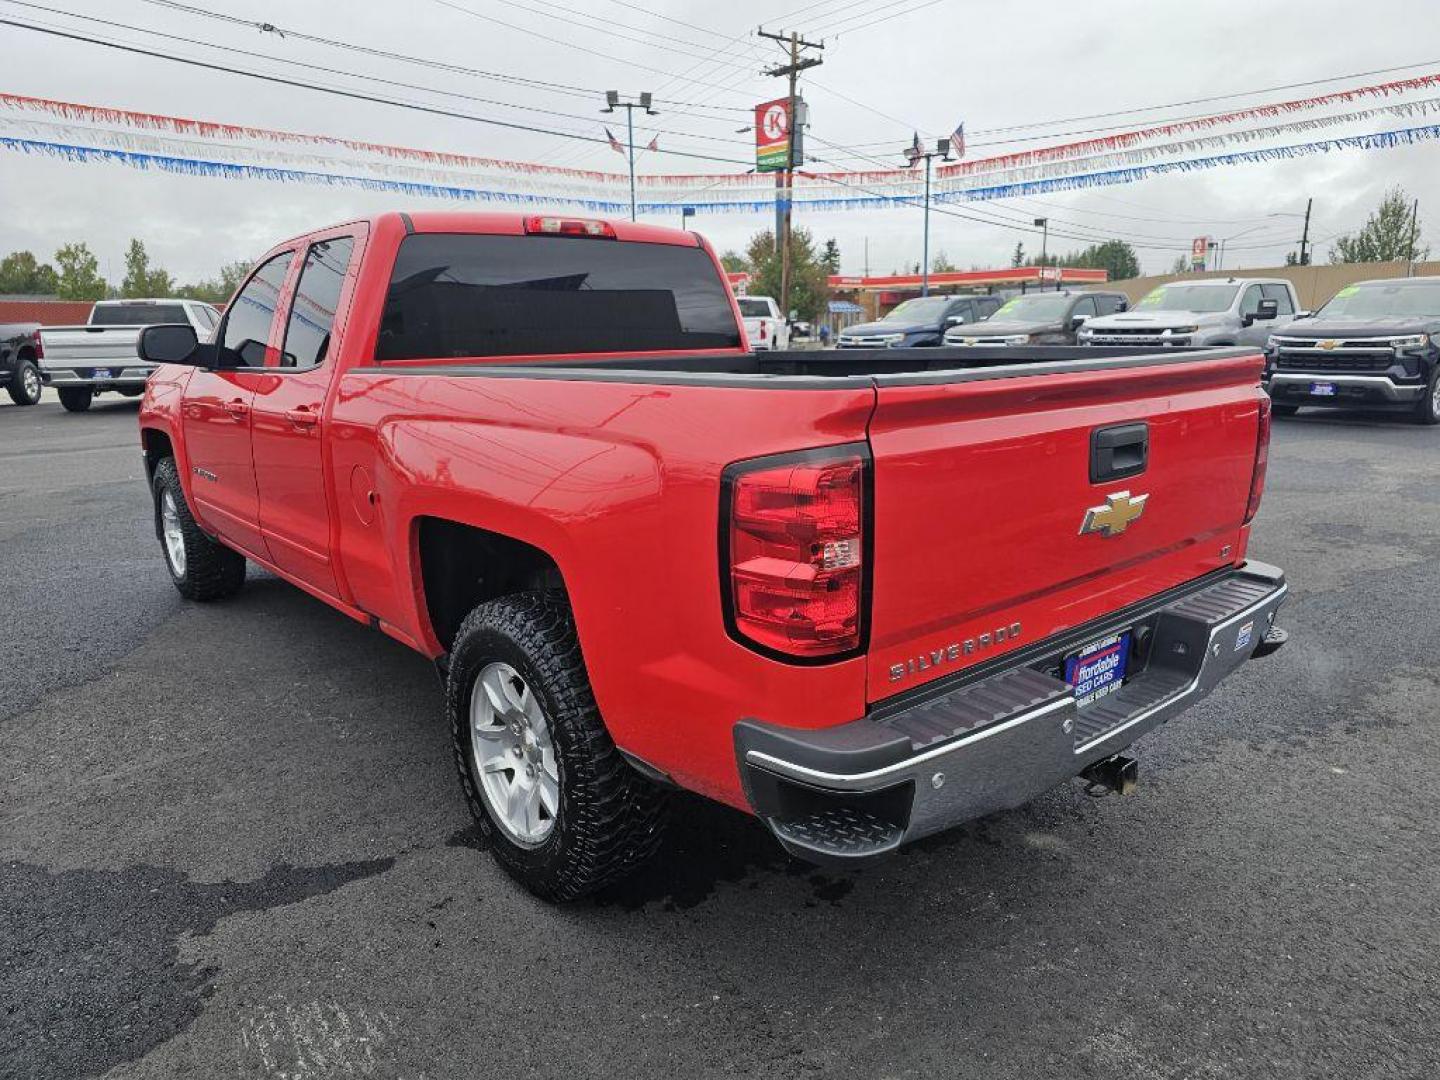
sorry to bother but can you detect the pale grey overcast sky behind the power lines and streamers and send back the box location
[0,0,1440,281]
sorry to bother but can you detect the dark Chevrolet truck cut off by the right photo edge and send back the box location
[1266,278,1440,423]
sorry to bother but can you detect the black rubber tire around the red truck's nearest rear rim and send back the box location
[445,592,668,901]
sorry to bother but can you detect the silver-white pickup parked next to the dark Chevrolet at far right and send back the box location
[1077,278,1300,346]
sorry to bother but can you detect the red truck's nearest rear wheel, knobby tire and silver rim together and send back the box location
[445,592,667,901]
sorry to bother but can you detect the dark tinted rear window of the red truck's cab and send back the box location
[376,233,740,360]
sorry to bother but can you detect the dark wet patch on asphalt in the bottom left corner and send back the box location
[0,858,395,1080]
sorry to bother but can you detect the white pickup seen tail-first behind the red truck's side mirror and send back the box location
[40,300,220,412]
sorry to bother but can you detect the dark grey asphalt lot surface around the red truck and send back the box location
[0,397,1440,1080]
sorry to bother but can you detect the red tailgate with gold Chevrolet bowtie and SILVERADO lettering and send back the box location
[867,351,1263,701]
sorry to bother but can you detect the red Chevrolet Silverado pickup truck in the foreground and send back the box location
[137,212,1286,899]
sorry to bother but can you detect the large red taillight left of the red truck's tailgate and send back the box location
[724,448,867,658]
